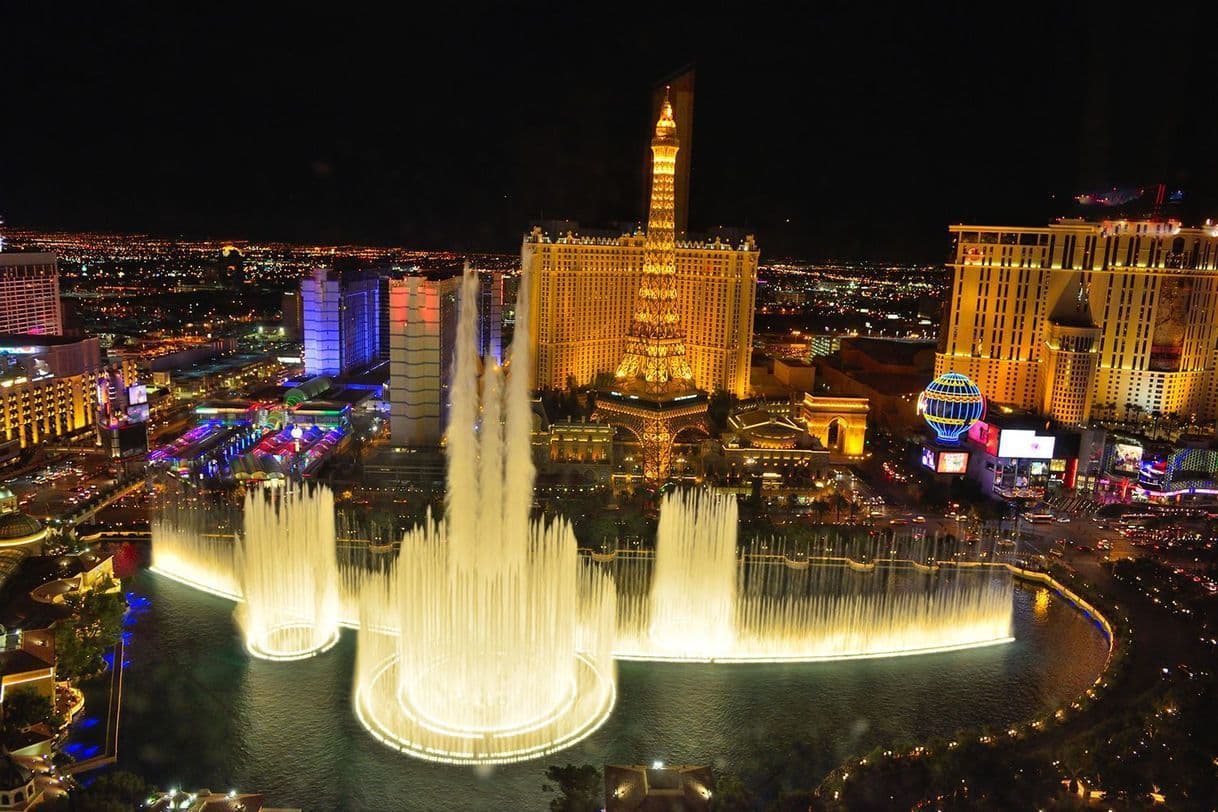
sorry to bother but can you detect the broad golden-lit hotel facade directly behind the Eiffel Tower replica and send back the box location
[520,228,759,397]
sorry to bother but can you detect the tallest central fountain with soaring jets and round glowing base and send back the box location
[354,275,615,763]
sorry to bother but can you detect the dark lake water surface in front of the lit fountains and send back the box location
[76,573,1106,810]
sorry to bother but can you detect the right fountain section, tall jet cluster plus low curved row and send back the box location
[615,494,1013,662]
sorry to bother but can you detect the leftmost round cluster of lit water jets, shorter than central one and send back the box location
[236,485,339,660]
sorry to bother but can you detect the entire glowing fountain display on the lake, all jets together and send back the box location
[152,275,1013,763]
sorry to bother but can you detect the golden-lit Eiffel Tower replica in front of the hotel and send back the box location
[597,93,706,485]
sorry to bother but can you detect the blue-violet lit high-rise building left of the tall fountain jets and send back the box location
[301,268,381,375]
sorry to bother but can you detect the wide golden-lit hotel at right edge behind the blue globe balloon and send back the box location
[935,220,1218,424]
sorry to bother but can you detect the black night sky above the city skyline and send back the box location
[0,1,1218,261]
